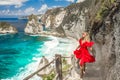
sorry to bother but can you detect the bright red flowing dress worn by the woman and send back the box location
[74,39,95,66]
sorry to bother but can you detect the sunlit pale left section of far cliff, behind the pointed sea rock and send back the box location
[41,8,66,36]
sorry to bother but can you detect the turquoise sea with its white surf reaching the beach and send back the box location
[0,19,76,80]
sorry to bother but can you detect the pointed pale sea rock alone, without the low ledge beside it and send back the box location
[24,14,43,34]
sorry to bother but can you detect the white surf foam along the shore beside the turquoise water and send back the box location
[2,36,76,80]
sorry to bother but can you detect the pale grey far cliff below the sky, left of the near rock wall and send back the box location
[41,0,91,39]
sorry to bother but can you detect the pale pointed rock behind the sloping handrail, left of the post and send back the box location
[37,56,53,77]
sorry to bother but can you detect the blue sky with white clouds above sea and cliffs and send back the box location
[0,0,84,17]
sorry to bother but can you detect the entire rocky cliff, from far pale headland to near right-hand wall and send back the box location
[25,0,120,80]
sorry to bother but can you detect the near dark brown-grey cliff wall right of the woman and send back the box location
[87,0,120,80]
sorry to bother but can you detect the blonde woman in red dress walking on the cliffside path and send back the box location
[74,32,95,80]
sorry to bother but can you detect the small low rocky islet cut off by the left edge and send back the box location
[0,22,18,34]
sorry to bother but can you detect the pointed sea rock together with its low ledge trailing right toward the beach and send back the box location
[24,14,65,37]
